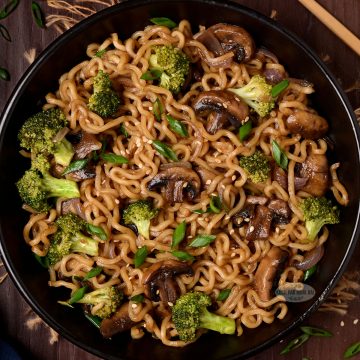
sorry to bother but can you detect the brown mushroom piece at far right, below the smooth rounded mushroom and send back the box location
[300,154,329,196]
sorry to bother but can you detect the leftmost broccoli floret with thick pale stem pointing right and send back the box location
[16,155,80,212]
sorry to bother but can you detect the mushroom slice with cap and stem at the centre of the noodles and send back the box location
[148,165,201,204]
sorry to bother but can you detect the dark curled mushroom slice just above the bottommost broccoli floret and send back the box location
[143,260,194,305]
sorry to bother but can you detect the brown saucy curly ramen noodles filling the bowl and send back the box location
[19,20,348,346]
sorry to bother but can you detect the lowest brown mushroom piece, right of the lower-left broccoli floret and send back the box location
[100,302,137,339]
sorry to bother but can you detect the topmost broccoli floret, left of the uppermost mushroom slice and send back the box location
[149,45,190,94]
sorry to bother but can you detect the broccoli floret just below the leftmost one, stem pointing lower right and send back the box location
[47,212,99,265]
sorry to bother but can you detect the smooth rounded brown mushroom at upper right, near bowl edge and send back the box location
[286,110,329,140]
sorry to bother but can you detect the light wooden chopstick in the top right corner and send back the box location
[298,0,360,56]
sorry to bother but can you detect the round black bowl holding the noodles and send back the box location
[0,0,360,360]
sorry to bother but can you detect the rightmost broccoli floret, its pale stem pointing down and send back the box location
[300,197,340,241]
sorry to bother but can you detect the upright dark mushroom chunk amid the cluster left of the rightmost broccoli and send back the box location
[245,205,272,241]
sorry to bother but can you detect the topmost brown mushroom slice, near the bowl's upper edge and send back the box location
[196,23,255,63]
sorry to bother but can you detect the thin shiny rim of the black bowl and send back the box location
[0,0,360,360]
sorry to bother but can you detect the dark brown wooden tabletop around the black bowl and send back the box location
[0,0,360,360]
